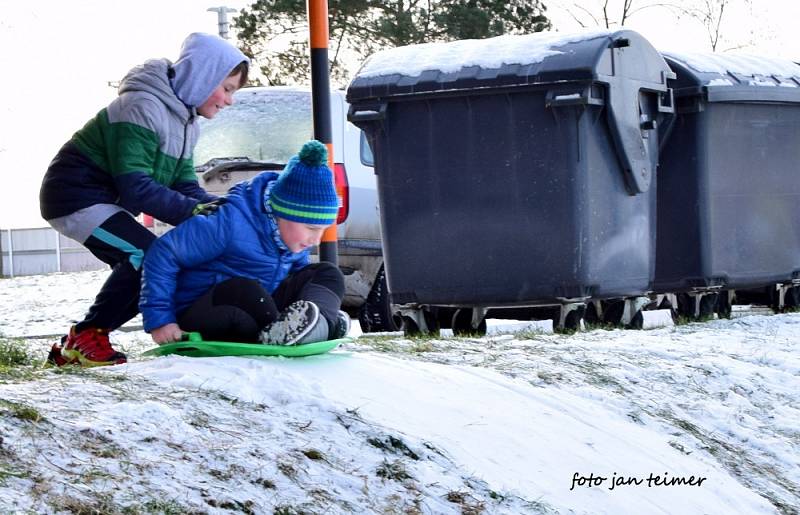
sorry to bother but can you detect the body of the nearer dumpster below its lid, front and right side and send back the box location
[368,84,655,306]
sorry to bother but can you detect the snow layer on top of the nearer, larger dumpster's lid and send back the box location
[358,29,612,77]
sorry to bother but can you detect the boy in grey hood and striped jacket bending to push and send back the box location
[39,33,249,366]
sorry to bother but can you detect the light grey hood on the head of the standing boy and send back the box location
[170,32,250,108]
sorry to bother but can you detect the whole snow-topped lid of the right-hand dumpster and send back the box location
[662,51,800,102]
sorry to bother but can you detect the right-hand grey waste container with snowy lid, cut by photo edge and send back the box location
[654,53,800,292]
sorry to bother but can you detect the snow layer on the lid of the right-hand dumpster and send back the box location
[662,51,800,88]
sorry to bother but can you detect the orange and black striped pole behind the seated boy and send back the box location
[307,0,339,265]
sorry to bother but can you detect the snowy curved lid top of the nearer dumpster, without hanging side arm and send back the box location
[347,30,671,103]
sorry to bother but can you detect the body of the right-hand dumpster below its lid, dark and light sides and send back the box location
[656,102,800,291]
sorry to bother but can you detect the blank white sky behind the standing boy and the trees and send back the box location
[0,0,800,229]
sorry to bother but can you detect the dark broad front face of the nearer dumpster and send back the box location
[375,91,586,305]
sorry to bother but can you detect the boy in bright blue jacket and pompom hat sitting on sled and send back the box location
[139,141,349,345]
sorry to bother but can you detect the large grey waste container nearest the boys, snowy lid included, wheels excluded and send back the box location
[347,30,672,306]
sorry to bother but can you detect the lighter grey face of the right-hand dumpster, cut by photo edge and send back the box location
[706,103,800,288]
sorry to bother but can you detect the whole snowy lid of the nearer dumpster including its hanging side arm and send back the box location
[347,30,674,195]
